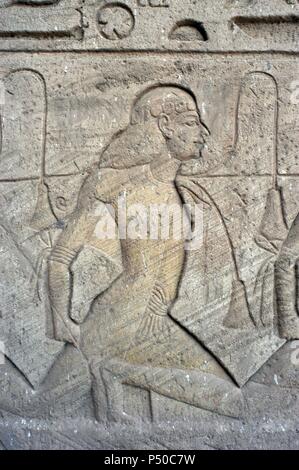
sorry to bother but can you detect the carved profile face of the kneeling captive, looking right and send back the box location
[168,111,207,161]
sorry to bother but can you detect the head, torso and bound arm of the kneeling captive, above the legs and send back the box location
[49,86,223,368]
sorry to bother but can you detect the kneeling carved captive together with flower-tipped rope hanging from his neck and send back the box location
[48,85,262,419]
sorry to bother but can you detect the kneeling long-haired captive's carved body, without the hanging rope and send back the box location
[49,86,246,413]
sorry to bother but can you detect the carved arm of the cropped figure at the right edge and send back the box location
[275,214,299,340]
